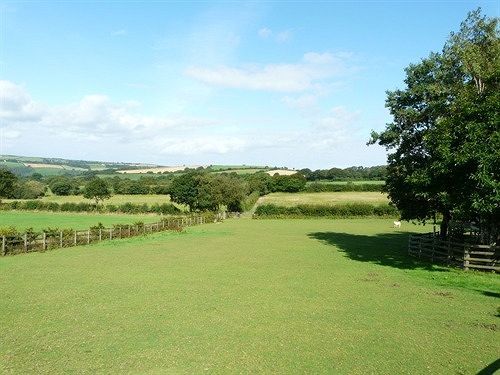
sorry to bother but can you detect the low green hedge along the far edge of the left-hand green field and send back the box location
[1,200,181,215]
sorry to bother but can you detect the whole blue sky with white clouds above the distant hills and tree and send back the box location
[0,0,500,169]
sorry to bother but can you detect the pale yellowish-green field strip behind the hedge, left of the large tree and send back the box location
[257,191,389,206]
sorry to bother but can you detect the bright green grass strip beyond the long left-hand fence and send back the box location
[0,211,160,231]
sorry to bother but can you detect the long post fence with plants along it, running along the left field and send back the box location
[0,215,214,256]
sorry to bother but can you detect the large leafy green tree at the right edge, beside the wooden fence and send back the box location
[370,10,500,242]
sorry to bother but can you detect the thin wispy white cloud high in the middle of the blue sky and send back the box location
[185,53,347,92]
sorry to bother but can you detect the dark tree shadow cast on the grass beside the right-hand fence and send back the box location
[308,232,447,272]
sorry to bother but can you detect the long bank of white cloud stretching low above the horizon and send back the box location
[0,81,376,167]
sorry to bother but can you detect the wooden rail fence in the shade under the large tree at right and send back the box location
[408,233,500,272]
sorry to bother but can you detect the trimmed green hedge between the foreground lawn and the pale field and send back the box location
[255,203,399,218]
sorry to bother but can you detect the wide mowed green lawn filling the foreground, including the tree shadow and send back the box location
[0,219,500,374]
